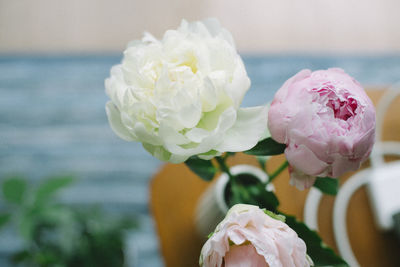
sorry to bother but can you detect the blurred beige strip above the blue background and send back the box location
[0,0,400,53]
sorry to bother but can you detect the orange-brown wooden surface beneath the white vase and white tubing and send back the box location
[150,91,400,267]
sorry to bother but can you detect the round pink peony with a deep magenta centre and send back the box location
[268,69,375,189]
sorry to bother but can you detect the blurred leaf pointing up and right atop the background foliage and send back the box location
[35,176,74,204]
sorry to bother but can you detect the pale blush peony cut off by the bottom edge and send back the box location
[200,204,312,267]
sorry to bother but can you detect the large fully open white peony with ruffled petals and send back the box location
[105,19,268,163]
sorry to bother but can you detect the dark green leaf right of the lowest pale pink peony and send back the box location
[284,214,349,267]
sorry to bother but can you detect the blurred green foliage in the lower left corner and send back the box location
[0,176,136,267]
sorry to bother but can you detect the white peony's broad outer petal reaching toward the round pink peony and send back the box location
[215,106,268,152]
